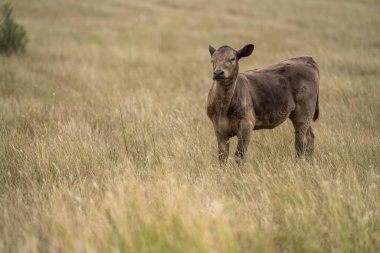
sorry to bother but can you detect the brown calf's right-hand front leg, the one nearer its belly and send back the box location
[235,119,253,165]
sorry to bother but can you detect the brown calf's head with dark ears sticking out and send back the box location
[209,44,254,83]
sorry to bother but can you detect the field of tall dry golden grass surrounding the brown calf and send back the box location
[0,0,380,253]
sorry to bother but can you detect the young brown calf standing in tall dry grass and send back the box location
[207,44,319,164]
